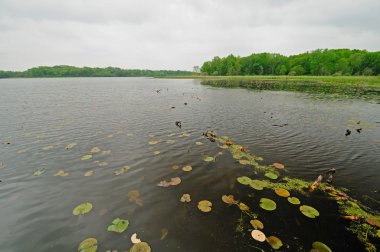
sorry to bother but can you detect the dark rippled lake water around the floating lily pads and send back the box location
[0,78,380,252]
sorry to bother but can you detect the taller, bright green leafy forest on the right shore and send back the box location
[201,49,380,76]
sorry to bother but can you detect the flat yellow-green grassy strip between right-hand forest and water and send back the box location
[160,75,380,88]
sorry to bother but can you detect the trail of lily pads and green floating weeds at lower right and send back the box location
[204,131,380,252]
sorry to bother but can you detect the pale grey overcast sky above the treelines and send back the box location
[0,0,380,70]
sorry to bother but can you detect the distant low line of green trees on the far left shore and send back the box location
[0,66,192,78]
